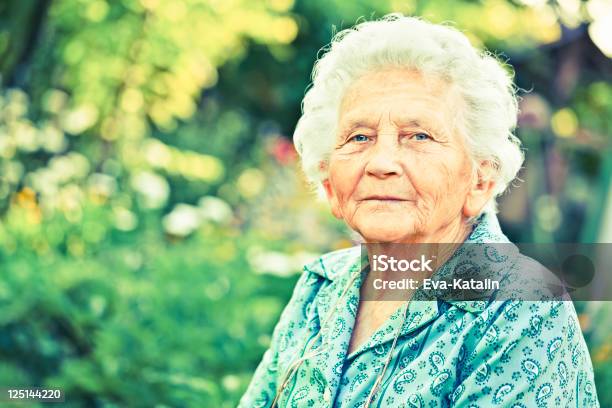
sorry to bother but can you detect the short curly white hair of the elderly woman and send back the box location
[293,13,524,213]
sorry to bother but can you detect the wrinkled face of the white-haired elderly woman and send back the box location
[323,68,493,242]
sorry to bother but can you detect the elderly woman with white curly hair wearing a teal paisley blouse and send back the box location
[240,14,599,408]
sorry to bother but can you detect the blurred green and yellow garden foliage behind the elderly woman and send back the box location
[0,0,612,406]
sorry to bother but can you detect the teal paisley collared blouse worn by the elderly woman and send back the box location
[239,213,599,408]
